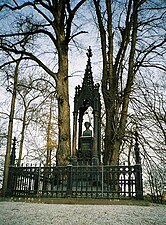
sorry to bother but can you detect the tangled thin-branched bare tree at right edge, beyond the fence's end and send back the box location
[131,73,166,201]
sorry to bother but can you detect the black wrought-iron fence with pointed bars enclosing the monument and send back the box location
[7,165,143,199]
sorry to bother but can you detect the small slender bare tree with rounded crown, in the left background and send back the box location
[16,70,52,166]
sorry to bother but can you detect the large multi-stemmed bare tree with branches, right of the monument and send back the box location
[93,0,166,164]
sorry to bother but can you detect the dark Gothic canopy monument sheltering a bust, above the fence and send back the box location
[72,47,101,165]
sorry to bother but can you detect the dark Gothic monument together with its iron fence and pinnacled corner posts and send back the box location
[6,47,143,200]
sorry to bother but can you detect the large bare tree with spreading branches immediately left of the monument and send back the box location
[0,0,86,164]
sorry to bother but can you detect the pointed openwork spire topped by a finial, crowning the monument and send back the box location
[82,46,94,90]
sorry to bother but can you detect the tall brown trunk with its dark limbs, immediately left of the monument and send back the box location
[0,0,86,167]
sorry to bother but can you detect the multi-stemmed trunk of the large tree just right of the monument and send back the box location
[94,0,138,165]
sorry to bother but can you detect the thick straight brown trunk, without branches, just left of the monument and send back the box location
[56,48,71,165]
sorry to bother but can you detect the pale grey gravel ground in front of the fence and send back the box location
[0,199,166,225]
